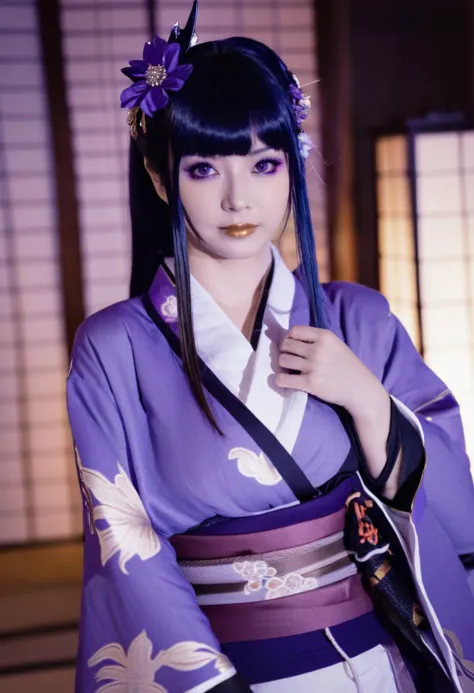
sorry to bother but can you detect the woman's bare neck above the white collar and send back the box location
[189,245,272,336]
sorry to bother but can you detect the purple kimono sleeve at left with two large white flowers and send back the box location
[67,330,250,693]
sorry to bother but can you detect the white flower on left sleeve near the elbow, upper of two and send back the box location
[76,450,161,575]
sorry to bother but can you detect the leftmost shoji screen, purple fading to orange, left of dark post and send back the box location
[0,0,78,545]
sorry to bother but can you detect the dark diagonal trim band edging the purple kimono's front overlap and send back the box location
[142,294,319,502]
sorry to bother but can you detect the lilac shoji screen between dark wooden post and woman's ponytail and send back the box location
[61,0,148,313]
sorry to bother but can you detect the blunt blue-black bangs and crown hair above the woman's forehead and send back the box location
[170,41,294,157]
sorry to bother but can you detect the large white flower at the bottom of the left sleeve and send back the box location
[88,630,232,693]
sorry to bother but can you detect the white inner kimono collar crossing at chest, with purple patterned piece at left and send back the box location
[150,246,307,449]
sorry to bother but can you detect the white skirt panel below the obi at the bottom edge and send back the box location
[251,645,415,693]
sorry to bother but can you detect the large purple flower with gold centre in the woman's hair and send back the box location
[120,36,193,116]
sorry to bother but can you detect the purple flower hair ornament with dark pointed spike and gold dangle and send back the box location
[120,0,197,139]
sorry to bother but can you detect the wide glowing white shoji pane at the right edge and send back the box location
[414,131,474,462]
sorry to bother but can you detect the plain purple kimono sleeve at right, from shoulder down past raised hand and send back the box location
[325,282,474,569]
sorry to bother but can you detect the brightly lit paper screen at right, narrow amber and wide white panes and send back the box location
[376,131,474,463]
